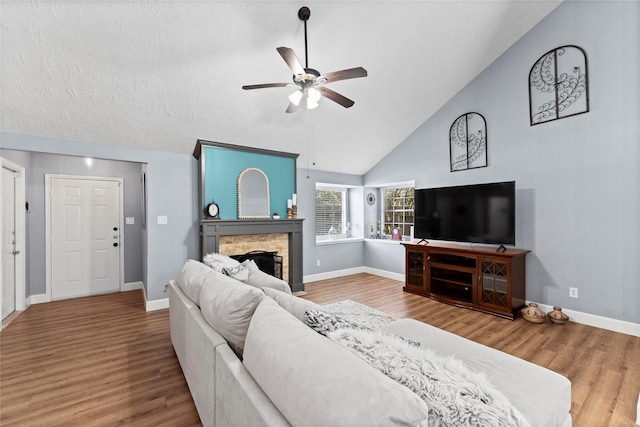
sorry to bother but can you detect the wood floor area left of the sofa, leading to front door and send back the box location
[0,291,200,427]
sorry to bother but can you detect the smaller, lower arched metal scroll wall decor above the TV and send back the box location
[449,113,487,172]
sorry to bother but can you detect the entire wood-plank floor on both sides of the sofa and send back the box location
[0,274,640,427]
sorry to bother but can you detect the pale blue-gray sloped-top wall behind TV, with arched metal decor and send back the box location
[364,1,640,323]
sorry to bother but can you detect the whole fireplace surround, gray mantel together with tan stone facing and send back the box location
[200,219,304,292]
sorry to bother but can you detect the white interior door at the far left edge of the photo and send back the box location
[2,167,16,320]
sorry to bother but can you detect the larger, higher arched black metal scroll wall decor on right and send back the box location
[529,45,589,126]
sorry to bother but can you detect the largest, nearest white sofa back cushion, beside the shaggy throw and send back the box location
[244,298,429,427]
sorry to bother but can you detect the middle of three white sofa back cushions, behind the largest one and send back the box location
[200,271,264,358]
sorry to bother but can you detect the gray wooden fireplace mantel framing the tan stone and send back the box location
[200,219,304,292]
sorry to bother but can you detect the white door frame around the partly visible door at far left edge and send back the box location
[0,157,27,329]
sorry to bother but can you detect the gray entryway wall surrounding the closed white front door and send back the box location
[0,150,143,295]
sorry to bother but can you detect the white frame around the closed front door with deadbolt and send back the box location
[44,173,124,302]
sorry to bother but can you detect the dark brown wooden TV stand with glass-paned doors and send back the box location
[403,241,529,320]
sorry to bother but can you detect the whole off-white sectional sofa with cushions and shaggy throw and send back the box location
[168,260,572,427]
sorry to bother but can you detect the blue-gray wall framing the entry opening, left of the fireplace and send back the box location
[0,132,199,301]
